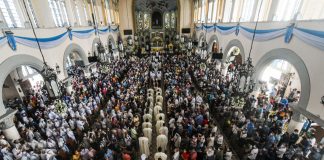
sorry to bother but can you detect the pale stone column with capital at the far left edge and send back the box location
[0,109,20,140]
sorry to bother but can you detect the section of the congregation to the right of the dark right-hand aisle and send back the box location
[189,50,324,160]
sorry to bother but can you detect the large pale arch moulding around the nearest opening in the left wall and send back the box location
[0,54,43,113]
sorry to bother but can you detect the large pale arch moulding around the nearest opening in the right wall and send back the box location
[253,48,311,109]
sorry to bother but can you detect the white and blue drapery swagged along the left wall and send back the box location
[0,26,119,50]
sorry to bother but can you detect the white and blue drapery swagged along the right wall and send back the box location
[195,23,324,50]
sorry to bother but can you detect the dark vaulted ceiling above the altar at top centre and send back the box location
[135,0,177,12]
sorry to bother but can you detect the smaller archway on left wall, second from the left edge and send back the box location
[63,43,89,76]
